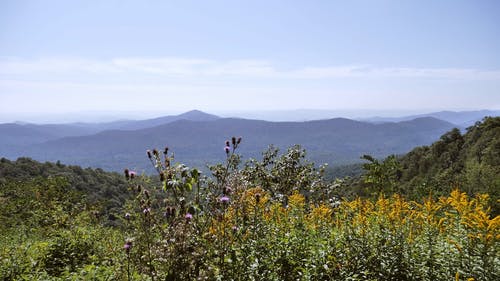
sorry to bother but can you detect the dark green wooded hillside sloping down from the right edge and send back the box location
[354,117,500,214]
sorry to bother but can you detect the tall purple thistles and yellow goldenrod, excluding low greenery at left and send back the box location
[116,138,500,280]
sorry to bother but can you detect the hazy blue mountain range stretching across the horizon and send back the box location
[0,110,496,172]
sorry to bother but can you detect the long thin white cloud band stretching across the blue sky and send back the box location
[0,57,500,81]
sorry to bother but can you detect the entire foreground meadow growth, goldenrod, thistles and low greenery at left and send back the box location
[0,138,500,281]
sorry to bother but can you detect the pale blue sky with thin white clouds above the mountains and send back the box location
[0,0,500,122]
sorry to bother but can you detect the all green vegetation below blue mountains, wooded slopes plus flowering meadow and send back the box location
[0,118,500,280]
